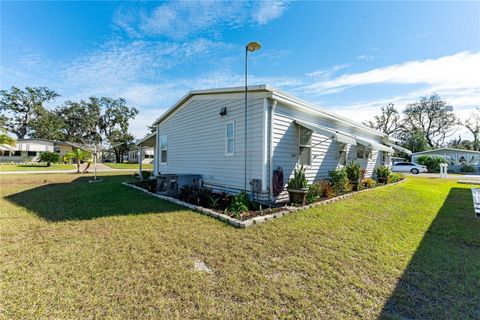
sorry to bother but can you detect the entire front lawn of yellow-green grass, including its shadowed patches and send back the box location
[0,173,480,319]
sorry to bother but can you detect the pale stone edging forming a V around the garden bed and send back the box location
[122,179,407,228]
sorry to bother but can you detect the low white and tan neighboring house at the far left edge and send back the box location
[0,138,87,162]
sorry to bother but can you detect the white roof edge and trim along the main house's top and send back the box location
[153,84,390,140]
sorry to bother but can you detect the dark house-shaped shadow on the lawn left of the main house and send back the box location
[6,175,180,222]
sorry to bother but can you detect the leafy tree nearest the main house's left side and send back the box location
[96,97,138,162]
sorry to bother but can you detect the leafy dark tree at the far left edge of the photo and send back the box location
[0,87,59,139]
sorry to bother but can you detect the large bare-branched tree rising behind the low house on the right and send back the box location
[404,93,458,148]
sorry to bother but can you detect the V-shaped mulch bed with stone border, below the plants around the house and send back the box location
[123,178,405,228]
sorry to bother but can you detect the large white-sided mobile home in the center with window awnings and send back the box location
[149,85,405,202]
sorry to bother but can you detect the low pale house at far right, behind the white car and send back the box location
[412,148,480,172]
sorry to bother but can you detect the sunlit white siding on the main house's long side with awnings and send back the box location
[272,104,382,202]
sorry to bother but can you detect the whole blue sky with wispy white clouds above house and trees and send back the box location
[0,1,480,138]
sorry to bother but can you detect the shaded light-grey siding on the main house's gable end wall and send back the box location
[156,93,266,189]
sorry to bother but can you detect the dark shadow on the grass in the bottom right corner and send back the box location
[380,188,480,319]
